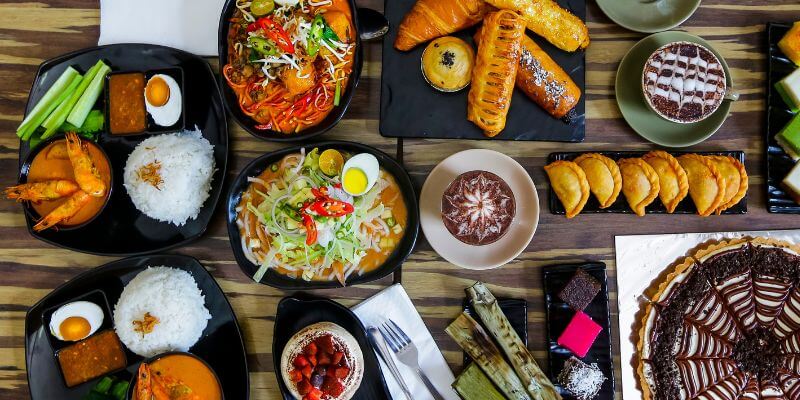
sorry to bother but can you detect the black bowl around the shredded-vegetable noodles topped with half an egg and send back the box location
[226,141,419,290]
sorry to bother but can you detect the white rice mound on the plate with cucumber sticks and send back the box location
[124,130,215,226]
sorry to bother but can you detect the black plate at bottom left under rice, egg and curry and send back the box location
[25,255,250,400]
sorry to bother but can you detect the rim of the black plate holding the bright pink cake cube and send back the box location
[542,261,617,393]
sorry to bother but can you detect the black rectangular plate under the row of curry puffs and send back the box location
[547,151,747,215]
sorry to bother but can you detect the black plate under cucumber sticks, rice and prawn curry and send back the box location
[19,44,228,256]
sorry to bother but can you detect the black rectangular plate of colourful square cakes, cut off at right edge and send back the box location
[765,23,800,214]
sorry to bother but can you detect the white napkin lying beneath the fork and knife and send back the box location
[353,283,459,400]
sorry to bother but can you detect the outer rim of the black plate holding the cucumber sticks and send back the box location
[17,43,228,257]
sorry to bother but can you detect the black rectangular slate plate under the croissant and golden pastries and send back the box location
[380,0,586,142]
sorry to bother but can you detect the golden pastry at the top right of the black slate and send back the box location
[486,0,589,51]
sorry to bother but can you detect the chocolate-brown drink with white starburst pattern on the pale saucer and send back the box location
[442,171,516,246]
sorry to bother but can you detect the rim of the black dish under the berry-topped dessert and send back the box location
[272,294,392,399]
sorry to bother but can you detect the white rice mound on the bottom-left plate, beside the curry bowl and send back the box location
[114,266,211,357]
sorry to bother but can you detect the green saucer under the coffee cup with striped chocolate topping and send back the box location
[615,31,733,147]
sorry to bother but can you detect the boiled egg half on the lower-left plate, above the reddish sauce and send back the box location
[50,301,103,342]
